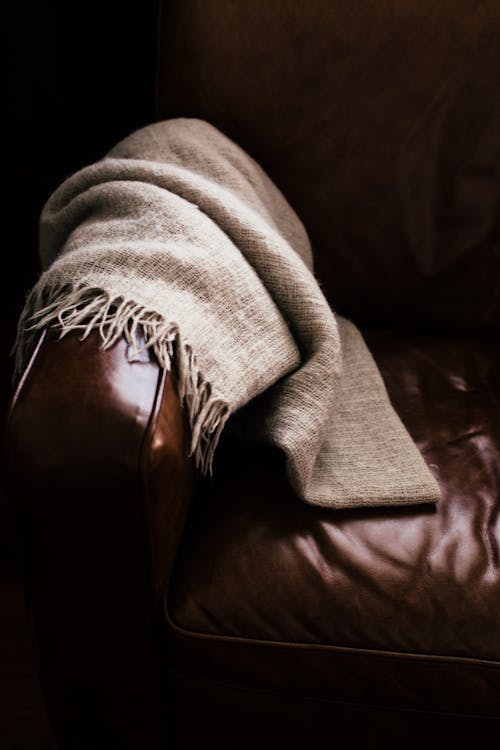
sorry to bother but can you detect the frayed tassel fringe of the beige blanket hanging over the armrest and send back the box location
[13,284,229,475]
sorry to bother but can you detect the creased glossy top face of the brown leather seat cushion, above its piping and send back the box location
[169,333,500,664]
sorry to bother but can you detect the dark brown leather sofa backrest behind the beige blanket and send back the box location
[157,0,500,331]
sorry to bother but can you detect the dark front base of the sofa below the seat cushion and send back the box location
[166,680,500,750]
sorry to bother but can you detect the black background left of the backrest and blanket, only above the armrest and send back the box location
[0,0,157,412]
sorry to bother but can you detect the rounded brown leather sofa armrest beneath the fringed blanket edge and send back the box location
[6,330,196,750]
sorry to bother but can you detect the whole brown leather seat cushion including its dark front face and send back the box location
[165,331,500,717]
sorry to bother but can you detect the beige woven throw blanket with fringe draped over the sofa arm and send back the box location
[13,119,439,508]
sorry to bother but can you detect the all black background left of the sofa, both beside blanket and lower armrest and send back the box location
[0,0,157,750]
